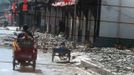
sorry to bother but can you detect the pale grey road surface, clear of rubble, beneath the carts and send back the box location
[0,48,91,75]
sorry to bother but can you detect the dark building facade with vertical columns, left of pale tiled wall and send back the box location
[14,0,101,43]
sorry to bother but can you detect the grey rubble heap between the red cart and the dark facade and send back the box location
[35,32,74,51]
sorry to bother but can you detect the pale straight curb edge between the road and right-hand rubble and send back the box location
[80,60,114,75]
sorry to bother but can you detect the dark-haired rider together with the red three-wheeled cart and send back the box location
[13,26,37,69]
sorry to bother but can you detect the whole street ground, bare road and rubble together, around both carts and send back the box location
[0,27,134,75]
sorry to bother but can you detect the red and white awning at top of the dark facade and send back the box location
[52,0,77,7]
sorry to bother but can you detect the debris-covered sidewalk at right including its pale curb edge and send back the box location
[72,48,134,75]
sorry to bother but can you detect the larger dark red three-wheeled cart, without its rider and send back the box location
[13,39,37,70]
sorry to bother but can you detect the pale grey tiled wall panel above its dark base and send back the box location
[100,0,134,39]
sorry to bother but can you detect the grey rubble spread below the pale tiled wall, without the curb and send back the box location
[80,48,134,75]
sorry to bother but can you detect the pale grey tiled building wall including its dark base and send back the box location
[95,0,134,47]
